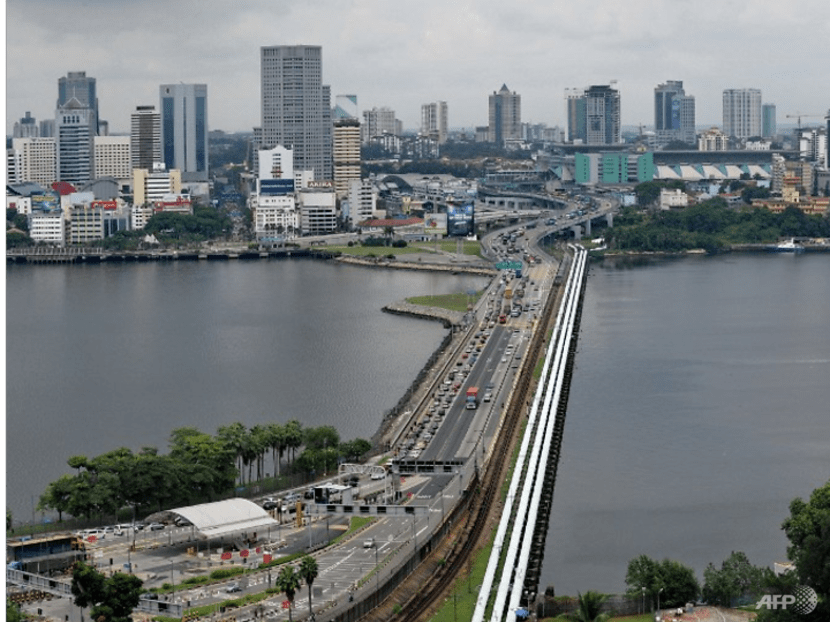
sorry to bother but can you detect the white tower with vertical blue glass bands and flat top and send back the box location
[159,84,208,182]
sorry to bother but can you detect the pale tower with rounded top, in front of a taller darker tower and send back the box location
[55,97,98,187]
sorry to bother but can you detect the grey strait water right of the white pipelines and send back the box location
[540,255,830,595]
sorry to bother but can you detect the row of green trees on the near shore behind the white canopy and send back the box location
[37,420,372,522]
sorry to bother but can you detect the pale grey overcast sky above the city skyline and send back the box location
[6,0,830,134]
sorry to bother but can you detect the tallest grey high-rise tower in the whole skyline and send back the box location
[260,45,332,180]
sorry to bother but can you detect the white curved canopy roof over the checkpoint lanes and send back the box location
[170,498,277,538]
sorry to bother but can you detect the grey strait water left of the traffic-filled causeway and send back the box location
[6,260,487,522]
